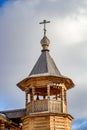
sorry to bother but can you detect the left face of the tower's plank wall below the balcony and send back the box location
[22,116,50,130]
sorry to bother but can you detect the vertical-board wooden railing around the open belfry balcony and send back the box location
[26,100,66,113]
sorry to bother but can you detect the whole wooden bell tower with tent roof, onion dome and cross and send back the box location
[17,20,74,130]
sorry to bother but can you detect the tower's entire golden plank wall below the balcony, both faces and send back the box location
[22,115,71,130]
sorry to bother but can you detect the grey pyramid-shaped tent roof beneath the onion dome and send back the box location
[29,51,62,77]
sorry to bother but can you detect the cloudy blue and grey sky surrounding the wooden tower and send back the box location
[0,0,87,130]
